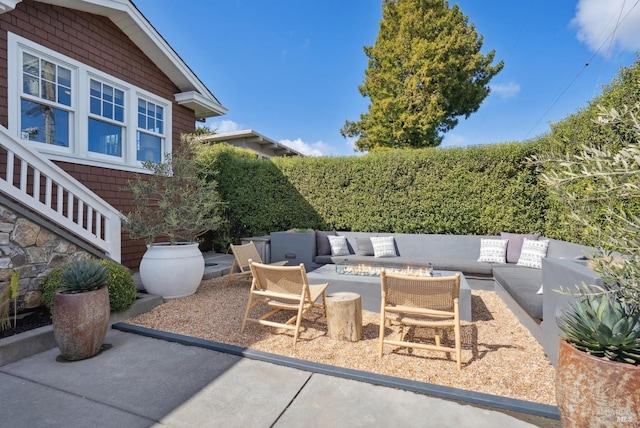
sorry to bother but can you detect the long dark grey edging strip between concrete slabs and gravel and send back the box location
[111,322,560,420]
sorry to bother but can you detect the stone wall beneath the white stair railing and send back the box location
[0,205,92,311]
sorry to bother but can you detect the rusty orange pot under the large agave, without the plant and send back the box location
[556,340,640,428]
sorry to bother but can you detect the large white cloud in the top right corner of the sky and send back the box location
[571,0,640,55]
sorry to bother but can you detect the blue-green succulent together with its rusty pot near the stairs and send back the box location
[52,260,110,361]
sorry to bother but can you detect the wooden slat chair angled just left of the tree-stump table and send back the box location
[241,261,329,346]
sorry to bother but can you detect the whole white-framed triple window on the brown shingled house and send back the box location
[7,32,172,171]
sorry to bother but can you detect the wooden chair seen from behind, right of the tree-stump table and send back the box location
[379,271,462,370]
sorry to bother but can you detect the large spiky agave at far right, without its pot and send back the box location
[558,294,640,365]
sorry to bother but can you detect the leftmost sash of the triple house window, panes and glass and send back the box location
[20,52,73,147]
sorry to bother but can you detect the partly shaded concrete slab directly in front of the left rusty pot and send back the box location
[0,330,240,426]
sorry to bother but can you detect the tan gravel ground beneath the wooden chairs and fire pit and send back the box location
[127,277,556,405]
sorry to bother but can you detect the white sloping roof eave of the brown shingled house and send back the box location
[0,0,227,119]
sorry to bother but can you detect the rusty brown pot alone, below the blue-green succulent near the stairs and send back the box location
[53,287,110,361]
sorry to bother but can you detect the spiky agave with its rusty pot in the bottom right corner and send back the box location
[556,291,640,427]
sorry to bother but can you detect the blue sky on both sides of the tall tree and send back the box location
[133,0,640,156]
